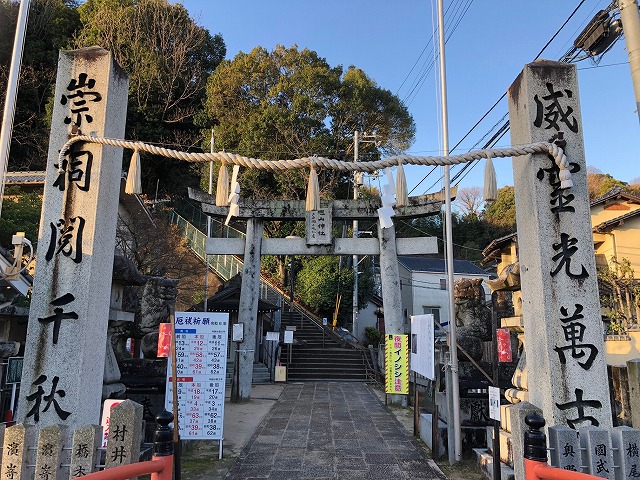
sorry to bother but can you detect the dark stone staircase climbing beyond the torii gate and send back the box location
[280,309,367,382]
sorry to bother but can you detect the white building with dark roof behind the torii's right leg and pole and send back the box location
[398,256,490,333]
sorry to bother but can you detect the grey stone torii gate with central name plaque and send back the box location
[189,189,443,401]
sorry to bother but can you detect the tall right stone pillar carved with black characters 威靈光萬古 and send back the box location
[508,60,612,428]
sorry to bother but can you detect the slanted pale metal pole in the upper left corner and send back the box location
[0,0,31,213]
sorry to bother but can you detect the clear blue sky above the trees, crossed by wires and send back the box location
[182,0,640,195]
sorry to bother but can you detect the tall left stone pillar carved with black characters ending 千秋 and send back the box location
[18,47,129,427]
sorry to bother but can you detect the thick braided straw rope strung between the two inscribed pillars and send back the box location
[58,135,573,188]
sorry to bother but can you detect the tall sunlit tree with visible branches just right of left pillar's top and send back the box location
[74,0,226,193]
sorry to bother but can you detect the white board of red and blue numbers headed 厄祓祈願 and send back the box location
[165,312,229,440]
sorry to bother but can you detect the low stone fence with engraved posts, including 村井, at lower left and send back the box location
[0,400,149,480]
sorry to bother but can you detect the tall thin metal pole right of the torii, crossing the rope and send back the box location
[438,0,462,463]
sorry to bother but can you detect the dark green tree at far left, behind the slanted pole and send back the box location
[0,0,80,170]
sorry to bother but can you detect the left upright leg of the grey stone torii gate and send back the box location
[238,217,264,401]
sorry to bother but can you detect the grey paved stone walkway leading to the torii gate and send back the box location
[226,382,444,480]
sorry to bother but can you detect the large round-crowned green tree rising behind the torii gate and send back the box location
[198,45,415,198]
